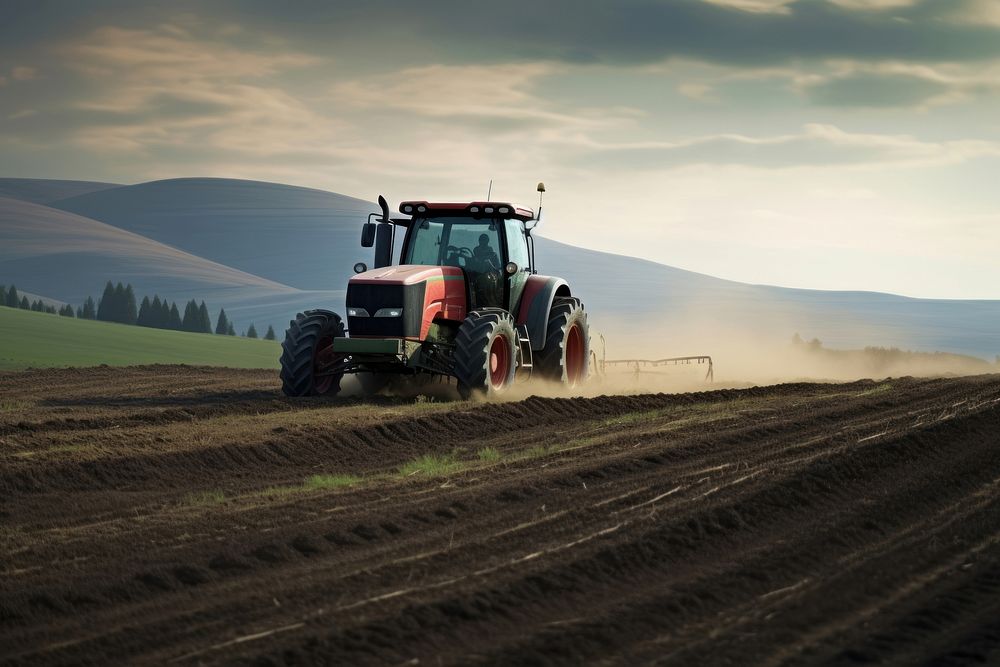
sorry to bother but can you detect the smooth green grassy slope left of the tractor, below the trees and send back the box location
[0,307,280,370]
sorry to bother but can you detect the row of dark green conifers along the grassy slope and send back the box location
[0,280,276,340]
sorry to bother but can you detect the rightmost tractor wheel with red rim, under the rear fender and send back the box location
[535,297,590,387]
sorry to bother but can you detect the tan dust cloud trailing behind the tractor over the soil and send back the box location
[340,313,1000,401]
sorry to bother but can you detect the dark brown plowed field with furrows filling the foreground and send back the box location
[0,367,1000,665]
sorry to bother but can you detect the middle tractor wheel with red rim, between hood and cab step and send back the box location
[455,311,517,399]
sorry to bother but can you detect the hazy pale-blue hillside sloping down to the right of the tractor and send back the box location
[536,239,1000,360]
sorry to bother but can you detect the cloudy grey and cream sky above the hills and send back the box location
[0,0,1000,299]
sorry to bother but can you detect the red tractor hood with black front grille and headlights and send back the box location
[347,264,466,340]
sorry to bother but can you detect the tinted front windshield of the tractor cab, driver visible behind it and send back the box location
[403,217,503,272]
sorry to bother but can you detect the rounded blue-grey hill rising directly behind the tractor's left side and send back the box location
[53,178,376,290]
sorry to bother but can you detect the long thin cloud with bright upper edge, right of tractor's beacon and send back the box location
[572,124,1000,171]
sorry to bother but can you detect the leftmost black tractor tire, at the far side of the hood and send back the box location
[281,310,344,396]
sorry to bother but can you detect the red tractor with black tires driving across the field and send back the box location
[281,183,590,398]
